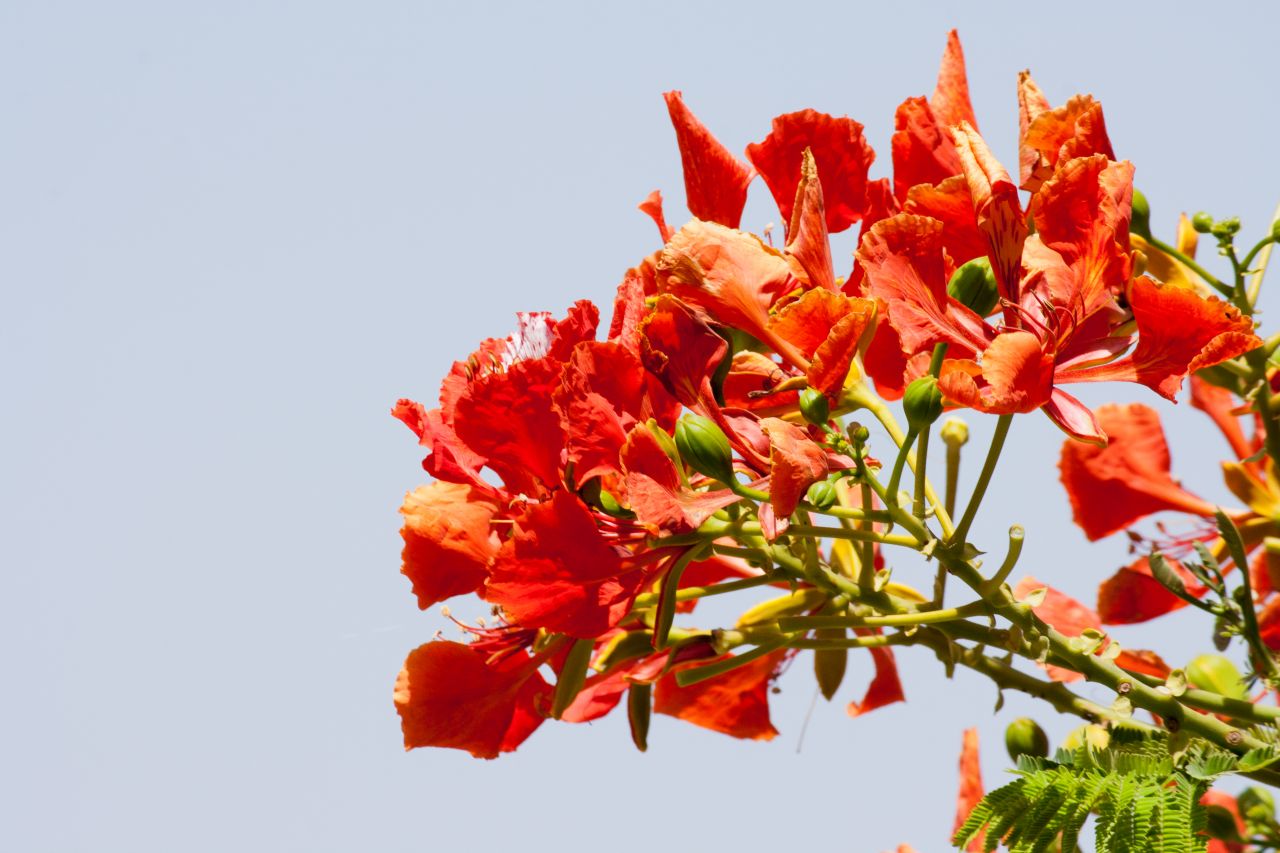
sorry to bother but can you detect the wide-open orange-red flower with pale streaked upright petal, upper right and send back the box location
[858,124,1261,442]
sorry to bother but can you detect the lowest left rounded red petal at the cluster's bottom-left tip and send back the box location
[396,640,550,758]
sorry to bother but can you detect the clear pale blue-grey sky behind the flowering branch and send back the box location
[0,0,1280,853]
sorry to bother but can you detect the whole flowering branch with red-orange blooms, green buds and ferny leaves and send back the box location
[393,32,1280,852]
